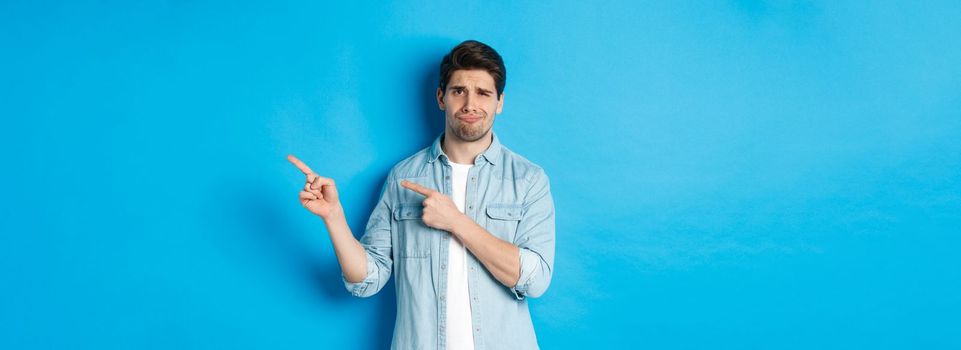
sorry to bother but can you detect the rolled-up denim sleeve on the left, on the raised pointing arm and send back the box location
[341,176,394,298]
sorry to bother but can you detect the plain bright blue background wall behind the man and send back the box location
[0,0,961,349]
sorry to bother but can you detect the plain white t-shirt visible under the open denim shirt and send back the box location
[447,162,474,350]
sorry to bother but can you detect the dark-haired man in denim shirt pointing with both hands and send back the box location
[288,41,554,349]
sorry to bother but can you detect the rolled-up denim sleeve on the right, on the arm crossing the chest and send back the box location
[511,169,554,300]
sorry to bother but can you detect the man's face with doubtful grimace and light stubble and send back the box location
[437,69,504,142]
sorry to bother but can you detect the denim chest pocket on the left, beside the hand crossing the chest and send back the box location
[393,203,439,258]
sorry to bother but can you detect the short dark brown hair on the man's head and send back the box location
[440,40,507,98]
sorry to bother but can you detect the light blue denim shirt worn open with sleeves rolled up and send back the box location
[344,133,554,350]
